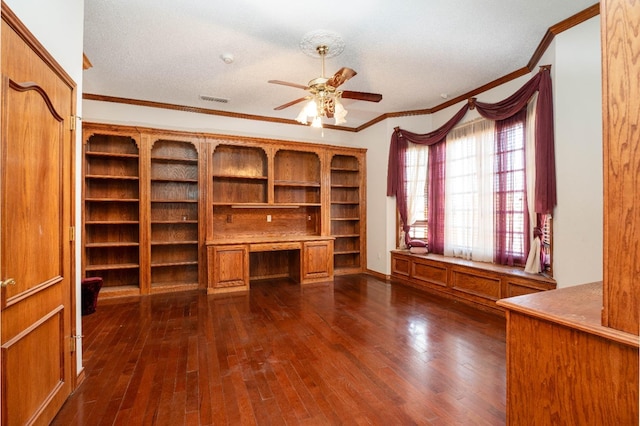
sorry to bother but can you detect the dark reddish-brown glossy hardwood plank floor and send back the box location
[53,275,506,426]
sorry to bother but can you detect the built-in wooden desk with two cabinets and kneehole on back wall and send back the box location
[207,235,334,294]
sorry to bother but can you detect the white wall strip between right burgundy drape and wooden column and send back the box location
[553,16,603,287]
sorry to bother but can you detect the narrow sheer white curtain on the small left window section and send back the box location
[406,143,429,243]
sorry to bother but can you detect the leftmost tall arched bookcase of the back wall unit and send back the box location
[83,133,140,294]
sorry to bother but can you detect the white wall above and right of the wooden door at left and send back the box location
[5,0,84,372]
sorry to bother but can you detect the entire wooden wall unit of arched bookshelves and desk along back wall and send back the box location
[82,123,366,297]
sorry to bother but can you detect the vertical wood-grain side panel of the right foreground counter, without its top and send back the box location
[507,311,638,425]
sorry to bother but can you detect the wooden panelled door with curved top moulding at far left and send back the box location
[0,4,75,425]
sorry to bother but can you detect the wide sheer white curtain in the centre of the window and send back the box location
[444,119,495,262]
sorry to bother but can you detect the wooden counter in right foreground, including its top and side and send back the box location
[498,283,639,425]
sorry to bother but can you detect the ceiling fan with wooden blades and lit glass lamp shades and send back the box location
[269,44,382,127]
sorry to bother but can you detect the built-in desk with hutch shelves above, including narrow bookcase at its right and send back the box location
[205,138,365,294]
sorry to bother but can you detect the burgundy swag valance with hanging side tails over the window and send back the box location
[387,66,557,216]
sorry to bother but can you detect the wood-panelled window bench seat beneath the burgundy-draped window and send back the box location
[391,250,556,313]
